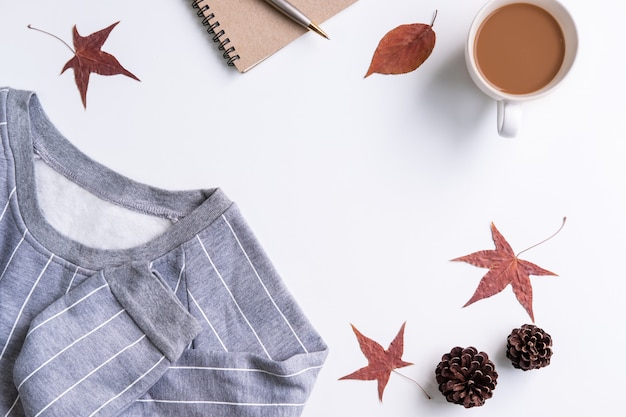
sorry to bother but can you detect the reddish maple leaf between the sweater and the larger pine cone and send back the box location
[339,323,413,401]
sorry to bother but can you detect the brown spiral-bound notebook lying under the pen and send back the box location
[192,0,357,72]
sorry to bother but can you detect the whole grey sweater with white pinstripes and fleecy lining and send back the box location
[0,88,327,417]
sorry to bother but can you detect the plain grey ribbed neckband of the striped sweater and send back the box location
[5,89,232,270]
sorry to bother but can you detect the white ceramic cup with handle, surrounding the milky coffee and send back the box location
[465,0,578,137]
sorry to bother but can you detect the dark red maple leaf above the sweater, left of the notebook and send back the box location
[61,21,139,108]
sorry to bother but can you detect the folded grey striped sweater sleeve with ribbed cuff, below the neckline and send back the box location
[14,263,200,417]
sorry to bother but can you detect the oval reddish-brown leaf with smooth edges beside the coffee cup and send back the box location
[365,12,437,77]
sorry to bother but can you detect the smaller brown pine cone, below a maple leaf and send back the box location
[506,324,552,371]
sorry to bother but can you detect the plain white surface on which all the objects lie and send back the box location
[0,0,626,417]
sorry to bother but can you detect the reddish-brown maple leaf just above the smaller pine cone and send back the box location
[452,219,565,322]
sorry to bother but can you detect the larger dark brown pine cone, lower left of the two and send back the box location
[435,346,498,408]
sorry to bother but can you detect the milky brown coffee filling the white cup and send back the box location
[474,3,565,94]
